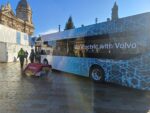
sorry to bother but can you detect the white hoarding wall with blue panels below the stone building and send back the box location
[0,24,31,62]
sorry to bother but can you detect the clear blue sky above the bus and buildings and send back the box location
[0,0,150,36]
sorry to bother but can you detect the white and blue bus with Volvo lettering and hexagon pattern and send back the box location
[41,12,150,90]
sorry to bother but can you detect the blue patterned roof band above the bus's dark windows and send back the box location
[41,12,150,41]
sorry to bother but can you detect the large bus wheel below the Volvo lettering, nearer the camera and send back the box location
[90,66,104,82]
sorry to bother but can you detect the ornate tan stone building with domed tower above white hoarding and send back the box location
[0,0,34,35]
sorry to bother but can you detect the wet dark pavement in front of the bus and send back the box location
[0,63,150,113]
